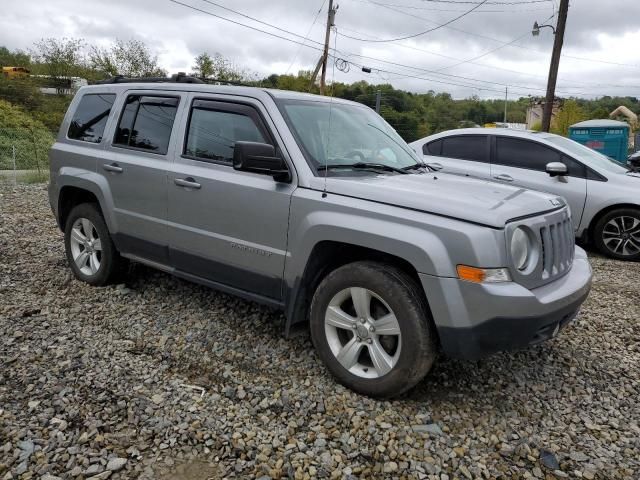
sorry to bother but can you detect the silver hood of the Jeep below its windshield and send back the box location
[312,173,566,228]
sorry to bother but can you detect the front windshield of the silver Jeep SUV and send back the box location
[277,100,422,172]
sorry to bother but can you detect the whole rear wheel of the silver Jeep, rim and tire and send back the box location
[64,203,125,285]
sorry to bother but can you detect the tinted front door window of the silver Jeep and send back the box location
[184,100,270,163]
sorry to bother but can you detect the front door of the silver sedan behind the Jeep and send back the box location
[491,136,587,230]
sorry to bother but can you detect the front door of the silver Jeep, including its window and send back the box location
[168,94,294,300]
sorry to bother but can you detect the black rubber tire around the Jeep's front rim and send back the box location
[310,262,438,398]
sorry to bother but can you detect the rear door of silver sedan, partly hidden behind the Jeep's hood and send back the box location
[422,135,491,179]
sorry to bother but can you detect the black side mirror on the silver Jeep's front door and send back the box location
[233,142,291,182]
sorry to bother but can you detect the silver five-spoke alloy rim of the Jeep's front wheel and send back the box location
[324,287,402,378]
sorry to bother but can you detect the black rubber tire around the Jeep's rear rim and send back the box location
[64,203,127,286]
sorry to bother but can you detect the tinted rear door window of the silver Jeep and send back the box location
[114,95,179,155]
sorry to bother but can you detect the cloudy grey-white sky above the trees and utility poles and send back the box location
[0,0,640,99]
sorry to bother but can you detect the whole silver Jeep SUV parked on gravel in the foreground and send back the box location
[49,76,591,397]
